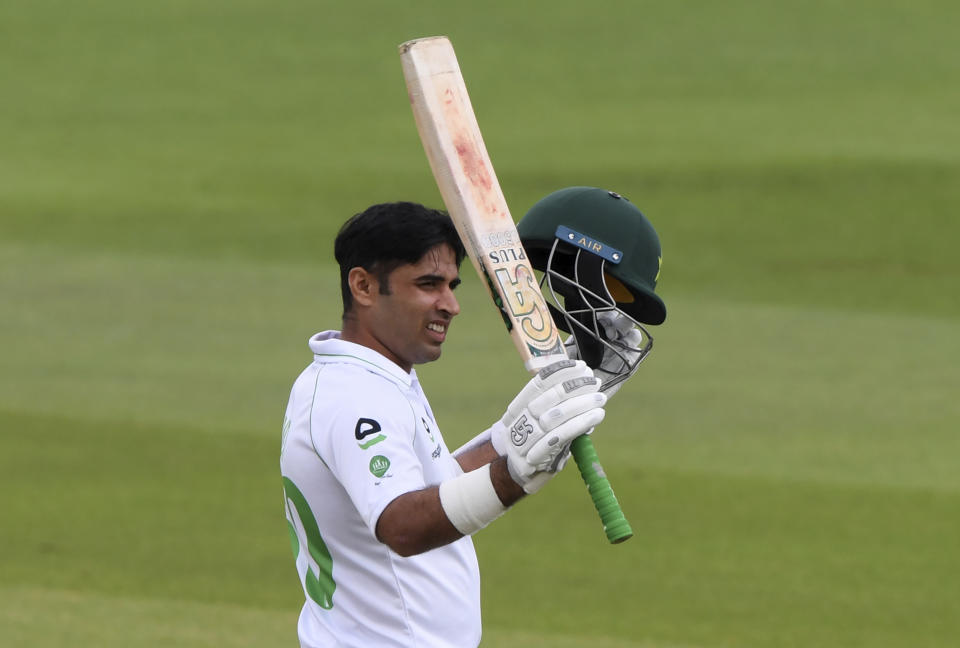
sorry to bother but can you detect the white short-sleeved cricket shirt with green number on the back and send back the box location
[280,331,480,648]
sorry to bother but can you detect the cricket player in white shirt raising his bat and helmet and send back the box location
[280,191,664,648]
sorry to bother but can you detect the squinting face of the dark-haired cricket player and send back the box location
[368,243,460,371]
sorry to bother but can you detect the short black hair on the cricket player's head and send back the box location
[333,202,466,315]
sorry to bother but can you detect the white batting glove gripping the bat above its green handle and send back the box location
[490,359,607,493]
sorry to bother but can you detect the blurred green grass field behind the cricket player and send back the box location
[0,0,960,648]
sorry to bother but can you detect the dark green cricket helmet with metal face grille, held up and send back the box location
[517,187,667,372]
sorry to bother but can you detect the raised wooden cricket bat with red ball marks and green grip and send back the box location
[400,36,633,544]
